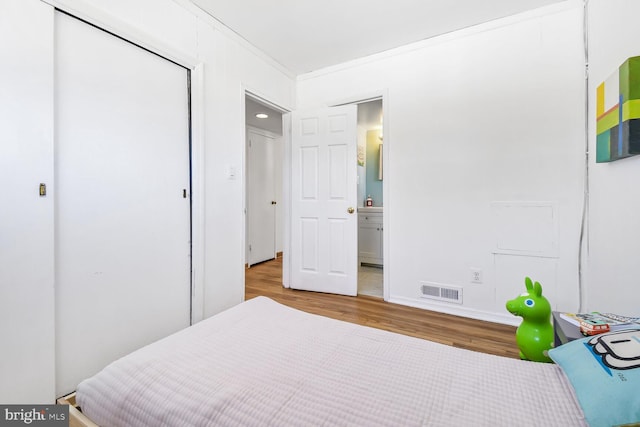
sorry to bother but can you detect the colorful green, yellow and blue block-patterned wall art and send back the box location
[596,56,640,163]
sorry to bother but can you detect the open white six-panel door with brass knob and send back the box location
[290,105,358,296]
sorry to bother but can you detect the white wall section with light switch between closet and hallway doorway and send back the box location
[198,10,295,316]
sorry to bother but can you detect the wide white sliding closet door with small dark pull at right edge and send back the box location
[55,13,191,395]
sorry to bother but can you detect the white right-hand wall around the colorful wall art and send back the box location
[585,0,640,315]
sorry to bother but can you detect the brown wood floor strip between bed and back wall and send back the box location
[245,258,518,358]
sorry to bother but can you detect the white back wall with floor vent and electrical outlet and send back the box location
[298,2,585,323]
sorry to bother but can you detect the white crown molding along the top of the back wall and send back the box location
[296,0,583,82]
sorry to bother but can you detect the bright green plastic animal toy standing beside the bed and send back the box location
[507,277,553,362]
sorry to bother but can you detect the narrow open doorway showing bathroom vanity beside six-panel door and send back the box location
[357,98,384,298]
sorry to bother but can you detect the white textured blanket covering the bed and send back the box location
[76,297,586,427]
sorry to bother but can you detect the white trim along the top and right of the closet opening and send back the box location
[47,0,205,324]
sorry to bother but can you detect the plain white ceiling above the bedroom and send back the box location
[191,0,568,75]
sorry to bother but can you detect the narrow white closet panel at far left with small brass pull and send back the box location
[0,0,55,404]
